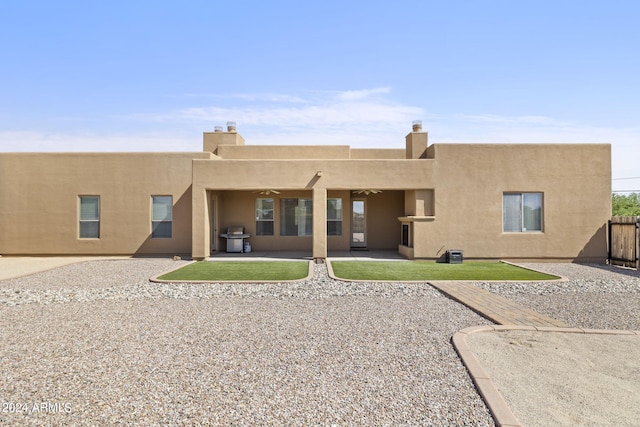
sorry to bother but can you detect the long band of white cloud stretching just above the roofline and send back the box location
[0,87,640,190]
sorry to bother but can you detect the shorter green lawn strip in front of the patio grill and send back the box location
[158,261,309,282]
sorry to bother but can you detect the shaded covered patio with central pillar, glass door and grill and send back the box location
[201,189,405,258]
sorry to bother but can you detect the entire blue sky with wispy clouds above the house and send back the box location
[0,0,640,191]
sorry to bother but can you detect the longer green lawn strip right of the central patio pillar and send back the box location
[331,261,558,281]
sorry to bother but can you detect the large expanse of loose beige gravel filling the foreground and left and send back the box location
[0,259,493,426]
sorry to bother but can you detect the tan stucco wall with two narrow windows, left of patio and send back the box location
[0,153,209,255]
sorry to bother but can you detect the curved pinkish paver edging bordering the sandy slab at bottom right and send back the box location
[451,325,640,427]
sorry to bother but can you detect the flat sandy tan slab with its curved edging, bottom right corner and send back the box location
[452,326,640,426]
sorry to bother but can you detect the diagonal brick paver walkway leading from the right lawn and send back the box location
[429,281,569,328]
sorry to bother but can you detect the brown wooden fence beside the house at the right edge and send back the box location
[609,216,640,269]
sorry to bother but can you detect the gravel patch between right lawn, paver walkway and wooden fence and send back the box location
[478,263,640,330]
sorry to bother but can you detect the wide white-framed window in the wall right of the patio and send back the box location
[502,193,542,233]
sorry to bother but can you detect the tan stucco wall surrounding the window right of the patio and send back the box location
[414,144,611,262]
